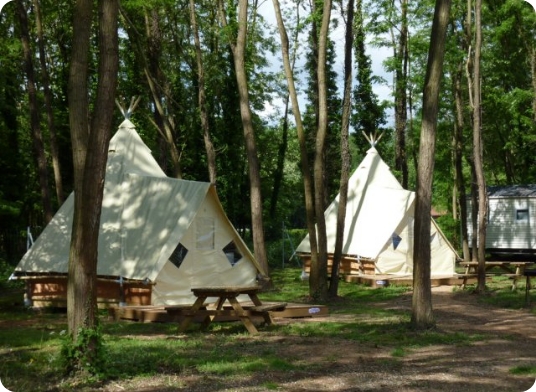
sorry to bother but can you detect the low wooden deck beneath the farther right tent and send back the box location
[344,274,477,288]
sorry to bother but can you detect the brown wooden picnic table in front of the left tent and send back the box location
[175,286,287,334]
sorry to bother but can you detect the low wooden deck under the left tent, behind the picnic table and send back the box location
[108,302,329,323]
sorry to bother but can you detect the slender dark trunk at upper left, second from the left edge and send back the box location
[33,0,64,205]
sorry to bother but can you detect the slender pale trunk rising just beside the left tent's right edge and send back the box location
[219,0,269,274]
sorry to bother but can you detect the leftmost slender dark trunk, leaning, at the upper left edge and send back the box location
[16,0,54,223]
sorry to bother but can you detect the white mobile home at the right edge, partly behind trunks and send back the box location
[467,185,536,255]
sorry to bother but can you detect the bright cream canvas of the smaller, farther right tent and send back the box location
[296,147,457,276]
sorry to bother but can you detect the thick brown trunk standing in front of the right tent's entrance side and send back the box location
[411,0,451,330]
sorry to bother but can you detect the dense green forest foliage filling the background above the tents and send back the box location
[0,0,536,274]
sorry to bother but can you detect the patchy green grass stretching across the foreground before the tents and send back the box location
[0,268,524,392]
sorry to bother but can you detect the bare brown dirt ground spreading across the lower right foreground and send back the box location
[93,288,536,392]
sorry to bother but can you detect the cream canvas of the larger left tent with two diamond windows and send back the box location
[15,120,264,305]
